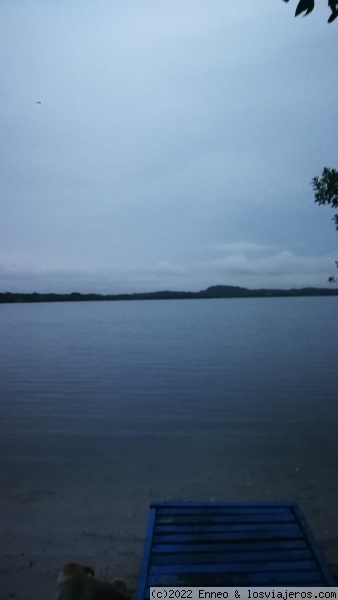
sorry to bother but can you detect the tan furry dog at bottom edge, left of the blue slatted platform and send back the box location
[55,563,129,600]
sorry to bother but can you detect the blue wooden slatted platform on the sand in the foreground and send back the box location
[136,502,337,600]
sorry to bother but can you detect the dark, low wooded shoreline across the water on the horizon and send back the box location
[0,285,338,304]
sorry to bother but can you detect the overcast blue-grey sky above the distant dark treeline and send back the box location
[0,0,338,293]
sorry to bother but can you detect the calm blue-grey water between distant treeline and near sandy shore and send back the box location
[0,297,338,494]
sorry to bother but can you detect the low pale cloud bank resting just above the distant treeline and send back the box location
[0,243,334,294]
